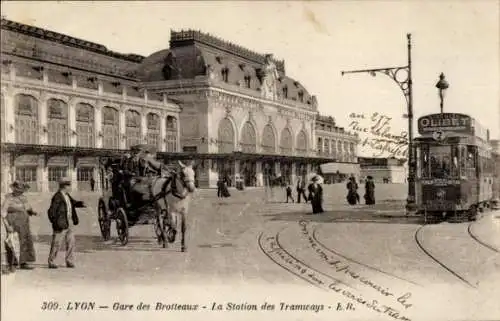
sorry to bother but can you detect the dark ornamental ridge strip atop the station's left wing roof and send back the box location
[1,18,144,63]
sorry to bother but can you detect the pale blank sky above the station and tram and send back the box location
[1,0,500,154]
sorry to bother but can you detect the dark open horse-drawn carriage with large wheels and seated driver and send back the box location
[98,158,175,248]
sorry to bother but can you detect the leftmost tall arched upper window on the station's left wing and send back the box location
[15,94,40,144]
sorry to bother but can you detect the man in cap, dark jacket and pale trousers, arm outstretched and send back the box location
[48,177,85,269]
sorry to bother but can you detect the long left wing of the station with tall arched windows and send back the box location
[1,19,180,192]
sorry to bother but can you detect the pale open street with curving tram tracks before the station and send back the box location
[2,184,500,320]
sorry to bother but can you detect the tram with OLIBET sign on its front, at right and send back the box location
[415,113,498,221]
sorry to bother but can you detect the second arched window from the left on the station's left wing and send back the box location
[47,98,69,146]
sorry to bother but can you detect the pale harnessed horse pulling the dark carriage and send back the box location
[151,161,196,252]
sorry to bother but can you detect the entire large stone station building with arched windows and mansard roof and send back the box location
[1,19,358,192]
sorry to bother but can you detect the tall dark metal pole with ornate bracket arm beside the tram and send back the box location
[342,33,417,213]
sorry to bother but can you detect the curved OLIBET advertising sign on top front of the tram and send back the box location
[418,113,472,134]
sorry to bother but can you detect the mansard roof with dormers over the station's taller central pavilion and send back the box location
[137,30,316,105]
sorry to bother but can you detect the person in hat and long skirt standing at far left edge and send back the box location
[1,181,37,272]
